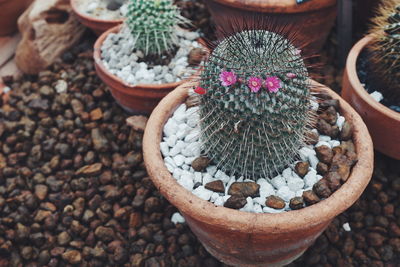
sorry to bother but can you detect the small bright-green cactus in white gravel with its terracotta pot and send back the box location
[94,0,202,113]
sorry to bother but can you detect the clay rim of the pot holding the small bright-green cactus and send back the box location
[93,24,200,94]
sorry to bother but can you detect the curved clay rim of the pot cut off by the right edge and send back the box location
[345,34,400,123]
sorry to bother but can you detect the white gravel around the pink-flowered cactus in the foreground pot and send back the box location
[160,95,345,213]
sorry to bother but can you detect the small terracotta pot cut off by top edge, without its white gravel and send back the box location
[71,0,124,35]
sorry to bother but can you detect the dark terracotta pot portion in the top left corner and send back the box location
[0,0,33,36]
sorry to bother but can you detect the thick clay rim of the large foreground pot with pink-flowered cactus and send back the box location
[143,81,373,233]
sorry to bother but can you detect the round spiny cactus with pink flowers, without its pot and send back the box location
[195,30,315,179]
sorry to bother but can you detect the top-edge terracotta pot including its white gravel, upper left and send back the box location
[71,0,128,35]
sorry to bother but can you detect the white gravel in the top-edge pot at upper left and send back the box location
[78,0,128,20]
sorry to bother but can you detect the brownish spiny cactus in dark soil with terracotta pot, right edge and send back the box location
[342,0,400,159]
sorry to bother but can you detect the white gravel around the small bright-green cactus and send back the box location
[101,25,200,86]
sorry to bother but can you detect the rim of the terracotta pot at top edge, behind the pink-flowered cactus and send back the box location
[211,0,337,13]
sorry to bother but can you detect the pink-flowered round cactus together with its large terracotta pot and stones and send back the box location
[143,26,373,266]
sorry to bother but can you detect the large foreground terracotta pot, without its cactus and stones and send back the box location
[143,81,373,267]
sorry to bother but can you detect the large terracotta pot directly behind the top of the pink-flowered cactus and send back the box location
[205,0,336,54]
